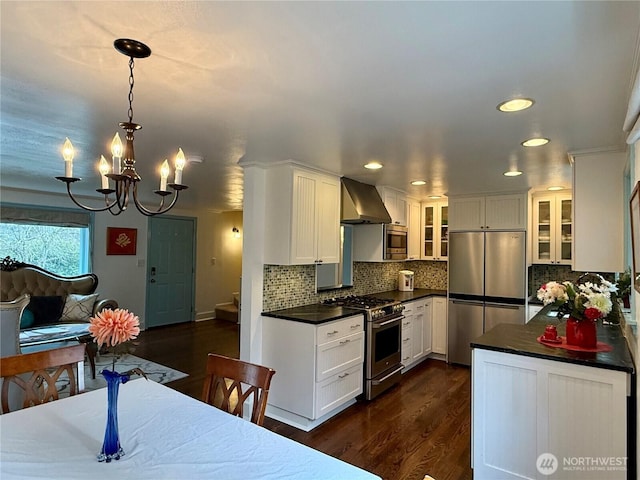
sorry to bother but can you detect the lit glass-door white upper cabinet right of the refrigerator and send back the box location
[531,192,573,265]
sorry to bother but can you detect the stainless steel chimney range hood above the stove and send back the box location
[340,177,391,224]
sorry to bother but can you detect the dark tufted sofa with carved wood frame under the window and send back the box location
[0,257,118,378]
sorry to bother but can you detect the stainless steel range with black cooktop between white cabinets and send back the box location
[323,295,404,400]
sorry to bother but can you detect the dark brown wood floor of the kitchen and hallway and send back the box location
[135,320,472,480]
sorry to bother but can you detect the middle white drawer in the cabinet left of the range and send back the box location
[316,331,364,382]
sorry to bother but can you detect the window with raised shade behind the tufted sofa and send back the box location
[0,204,92,276]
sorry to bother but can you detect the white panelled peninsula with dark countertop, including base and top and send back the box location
[471,306,636,480]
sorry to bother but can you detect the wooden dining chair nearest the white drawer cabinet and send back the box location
[202,353,276,425]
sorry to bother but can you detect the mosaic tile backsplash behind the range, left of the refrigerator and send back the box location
[262,261,447,312]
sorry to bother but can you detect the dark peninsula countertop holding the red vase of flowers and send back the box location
[471,306,635,373]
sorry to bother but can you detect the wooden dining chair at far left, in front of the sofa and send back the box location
[0,344,85,413]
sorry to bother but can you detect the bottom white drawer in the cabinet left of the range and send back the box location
[315,364,364,418]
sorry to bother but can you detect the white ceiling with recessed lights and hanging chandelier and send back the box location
[0,0,640,210]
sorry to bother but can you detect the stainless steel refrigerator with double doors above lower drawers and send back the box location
[447,232,527,365]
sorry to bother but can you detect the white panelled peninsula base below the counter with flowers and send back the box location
[471,348,634,480]
